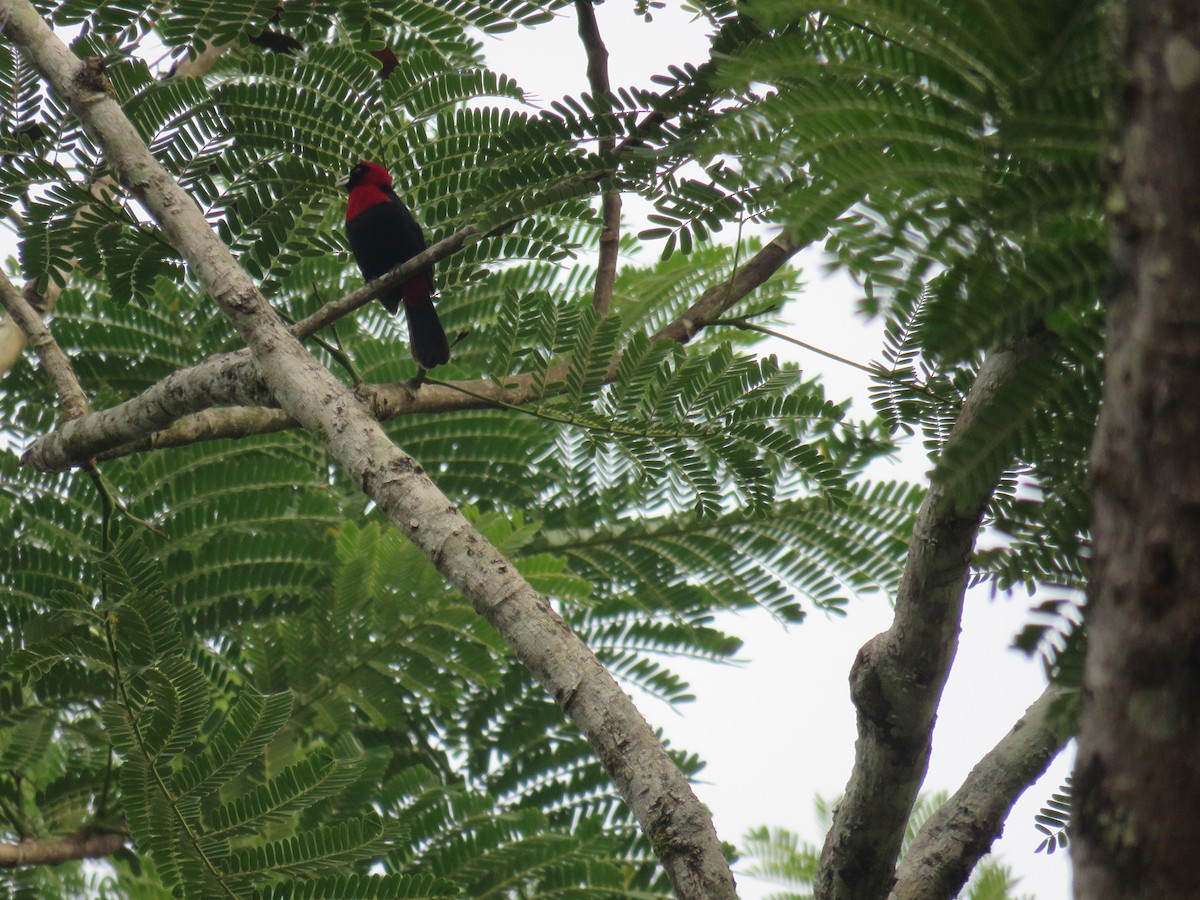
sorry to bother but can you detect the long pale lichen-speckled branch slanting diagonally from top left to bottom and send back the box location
[0,0,736,900]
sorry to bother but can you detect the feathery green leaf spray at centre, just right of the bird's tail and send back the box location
[472,296,845,515]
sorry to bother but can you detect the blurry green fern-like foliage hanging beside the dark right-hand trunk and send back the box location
[708,0,1108,614]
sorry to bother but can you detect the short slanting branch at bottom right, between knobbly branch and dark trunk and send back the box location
[889,684,1075,900]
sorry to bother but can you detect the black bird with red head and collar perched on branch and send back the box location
[338,162,450,368]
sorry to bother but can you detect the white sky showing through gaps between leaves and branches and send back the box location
[0,0,1070,900]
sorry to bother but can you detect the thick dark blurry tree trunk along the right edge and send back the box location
[1072,0,1200,900]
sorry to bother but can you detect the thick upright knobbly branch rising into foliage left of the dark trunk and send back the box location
[814,335,1055,900]
